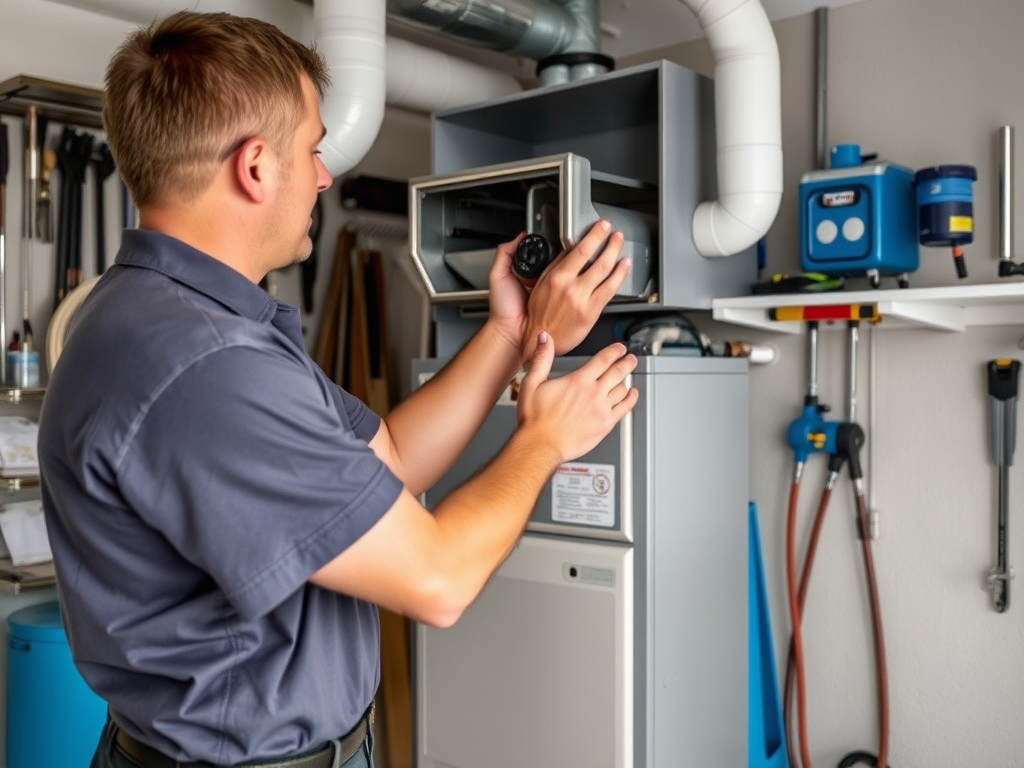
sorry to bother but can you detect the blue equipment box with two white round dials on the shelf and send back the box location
[800,162,920,287]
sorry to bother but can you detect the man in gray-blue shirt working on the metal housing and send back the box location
[39,12,637,768]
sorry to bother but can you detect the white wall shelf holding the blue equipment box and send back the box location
[712,280,1024,334]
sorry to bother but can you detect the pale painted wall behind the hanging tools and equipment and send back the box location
[0,0,1024,768]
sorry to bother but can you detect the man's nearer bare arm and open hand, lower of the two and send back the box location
[310,332,639,627]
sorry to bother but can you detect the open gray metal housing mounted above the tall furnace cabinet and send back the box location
[410,60,757,312]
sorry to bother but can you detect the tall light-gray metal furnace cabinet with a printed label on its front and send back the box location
[414,357,750,768]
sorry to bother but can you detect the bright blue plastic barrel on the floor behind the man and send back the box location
[7,602,106,768]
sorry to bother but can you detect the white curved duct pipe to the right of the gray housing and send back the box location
[681,0,782,256]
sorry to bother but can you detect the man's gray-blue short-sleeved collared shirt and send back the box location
[39,230,401,764]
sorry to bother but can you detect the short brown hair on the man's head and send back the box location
[103,11,330,207]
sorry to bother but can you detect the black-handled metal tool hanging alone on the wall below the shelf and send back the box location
[986,358,1021,613]
